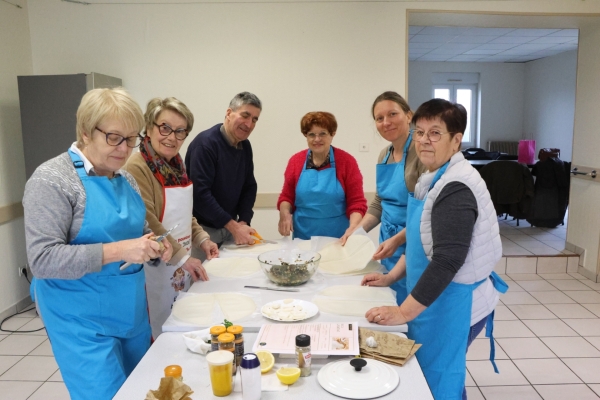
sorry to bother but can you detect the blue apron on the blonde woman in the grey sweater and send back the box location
[31,150,150,400]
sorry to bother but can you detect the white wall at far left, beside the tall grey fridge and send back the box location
[0,0,32,313]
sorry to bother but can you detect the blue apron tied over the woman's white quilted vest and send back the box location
[406,163,507,400]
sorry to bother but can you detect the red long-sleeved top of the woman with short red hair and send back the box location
[277,146,367,218]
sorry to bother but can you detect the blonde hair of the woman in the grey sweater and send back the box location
[76,87,144,149]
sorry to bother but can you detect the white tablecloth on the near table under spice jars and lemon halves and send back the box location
[114,333,433,400]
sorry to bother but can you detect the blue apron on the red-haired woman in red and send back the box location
[293,147,350,240]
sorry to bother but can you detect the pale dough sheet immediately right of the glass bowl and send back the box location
[319,235,375,275]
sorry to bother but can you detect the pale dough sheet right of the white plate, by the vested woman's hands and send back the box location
[312,285,398,317]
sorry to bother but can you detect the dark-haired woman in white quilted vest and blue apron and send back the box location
[362,99,507,400]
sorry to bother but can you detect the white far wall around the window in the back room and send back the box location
[408,61,525,149]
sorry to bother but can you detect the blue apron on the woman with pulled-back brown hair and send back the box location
[377,134,412,304]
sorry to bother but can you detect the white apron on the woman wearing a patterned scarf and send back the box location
[144,183,194,340]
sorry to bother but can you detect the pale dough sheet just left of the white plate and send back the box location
[173,293,256,326]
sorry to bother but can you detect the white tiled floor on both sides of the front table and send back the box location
[0,272,600,400]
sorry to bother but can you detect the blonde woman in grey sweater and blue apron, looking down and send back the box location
[23,88,172,400]
